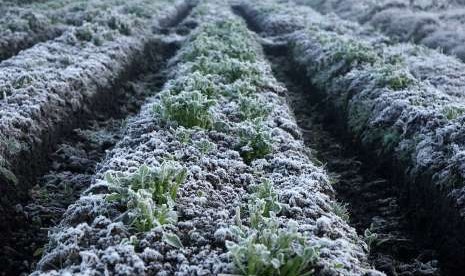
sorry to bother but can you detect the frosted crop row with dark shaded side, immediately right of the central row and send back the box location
[237,1,465,272]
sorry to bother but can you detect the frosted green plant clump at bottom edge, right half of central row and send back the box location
[226,180,318,276]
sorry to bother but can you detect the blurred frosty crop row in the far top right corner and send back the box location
[295,0,465,60]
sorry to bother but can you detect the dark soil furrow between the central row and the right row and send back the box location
[265,45,441,276]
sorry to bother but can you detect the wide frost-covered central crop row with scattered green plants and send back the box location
[30,2,378,275]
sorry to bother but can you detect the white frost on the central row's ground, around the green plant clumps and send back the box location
[34,1,381,275]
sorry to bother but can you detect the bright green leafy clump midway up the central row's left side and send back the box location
[153,91,216,129]
